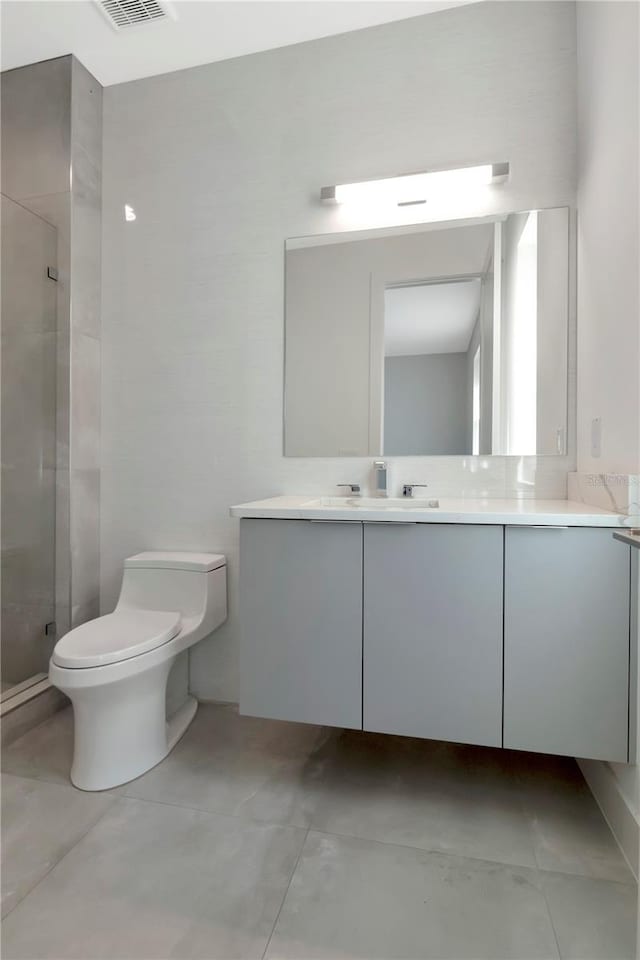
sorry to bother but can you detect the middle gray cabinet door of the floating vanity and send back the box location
[363,523,503,746]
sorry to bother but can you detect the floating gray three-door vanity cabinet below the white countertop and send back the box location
[240,518,635,762]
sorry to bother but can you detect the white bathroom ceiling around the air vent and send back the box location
[0,0,470,86]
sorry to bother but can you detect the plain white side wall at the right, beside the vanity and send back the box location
[577,0,640,880]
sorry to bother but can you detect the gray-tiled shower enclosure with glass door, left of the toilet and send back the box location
[0,56,102,743]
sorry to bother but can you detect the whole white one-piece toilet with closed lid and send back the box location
[49,552,227,790]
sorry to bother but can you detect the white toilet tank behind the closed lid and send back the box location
[116,550,227,637]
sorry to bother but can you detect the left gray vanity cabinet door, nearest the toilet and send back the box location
[240,519,362,729]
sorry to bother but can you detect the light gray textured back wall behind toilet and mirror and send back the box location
[101,2,575,699]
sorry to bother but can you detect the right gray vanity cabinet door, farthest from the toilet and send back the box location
[504,527,630,761]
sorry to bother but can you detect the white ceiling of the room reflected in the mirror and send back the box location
[384,280,480,357]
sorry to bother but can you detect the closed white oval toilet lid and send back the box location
[51,610,180,668]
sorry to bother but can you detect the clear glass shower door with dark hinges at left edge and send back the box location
[0,196,56,699]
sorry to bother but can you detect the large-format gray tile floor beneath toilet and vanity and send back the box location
[2,704,636,960]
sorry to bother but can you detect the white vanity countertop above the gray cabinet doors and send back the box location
[230,495,637,527]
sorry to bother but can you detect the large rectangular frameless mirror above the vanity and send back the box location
[284,207,569,457]
